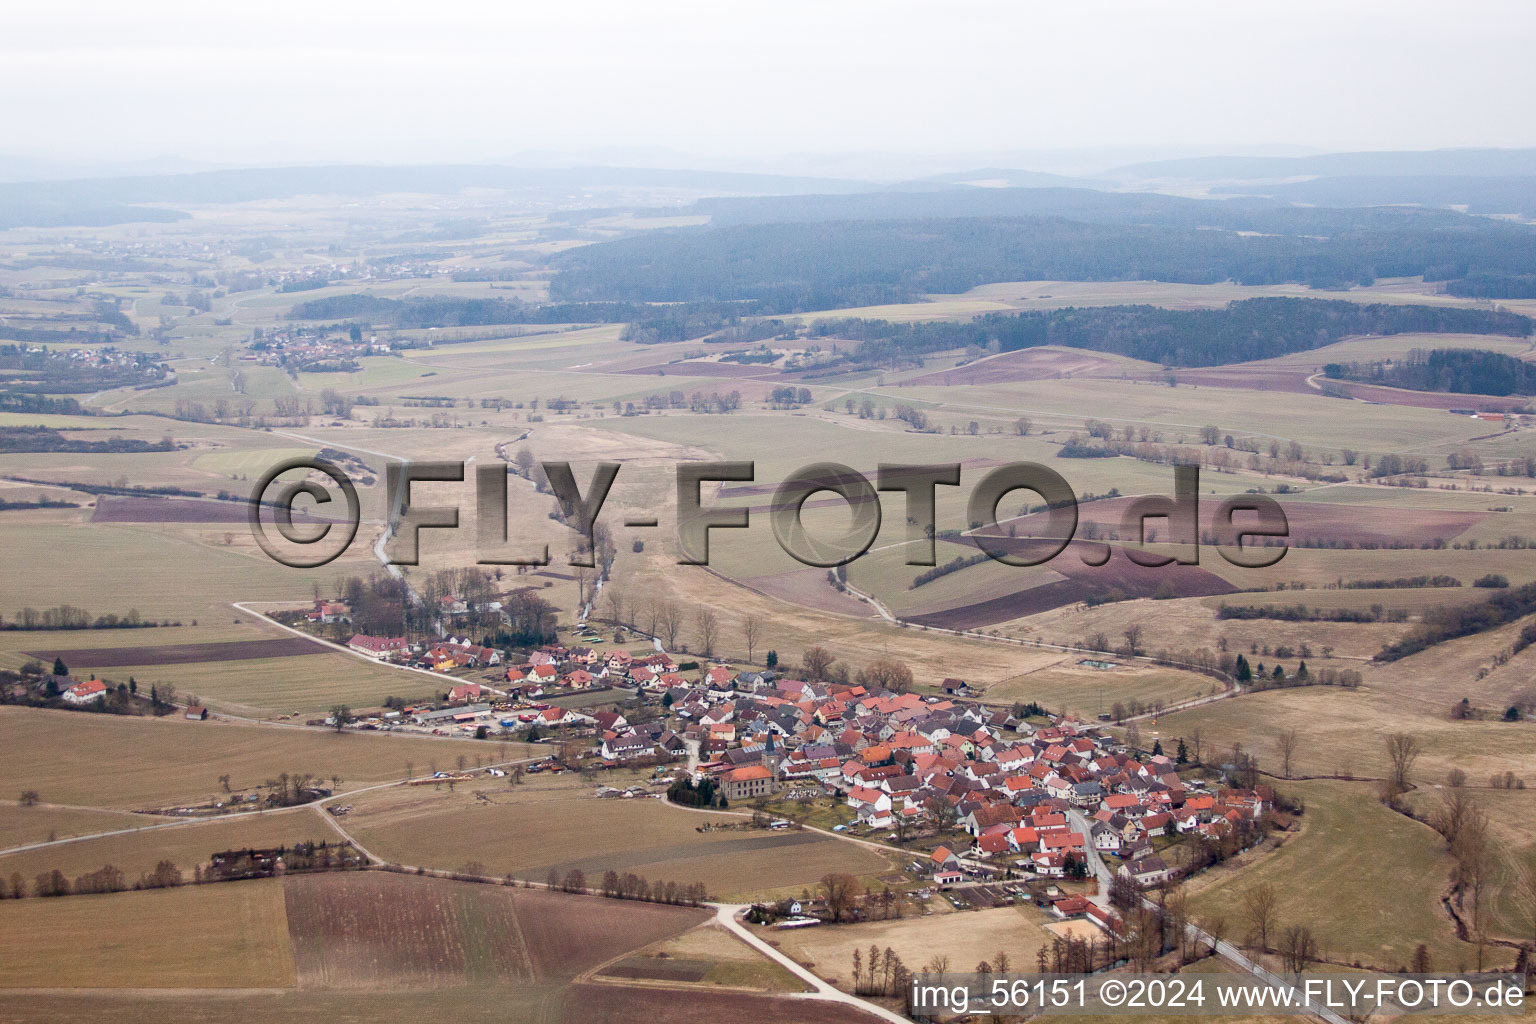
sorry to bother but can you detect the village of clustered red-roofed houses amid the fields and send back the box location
[310,597,1276,938]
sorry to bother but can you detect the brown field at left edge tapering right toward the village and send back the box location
[0,706,538,811]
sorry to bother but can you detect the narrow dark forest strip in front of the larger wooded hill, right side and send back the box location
[814,298,1536,367]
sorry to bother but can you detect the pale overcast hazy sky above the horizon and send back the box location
[0,0,1536,171]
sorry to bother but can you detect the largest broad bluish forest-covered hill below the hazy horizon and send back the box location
[550,210,1536,313]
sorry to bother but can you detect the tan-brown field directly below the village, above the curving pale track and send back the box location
[336,775,889,898]
